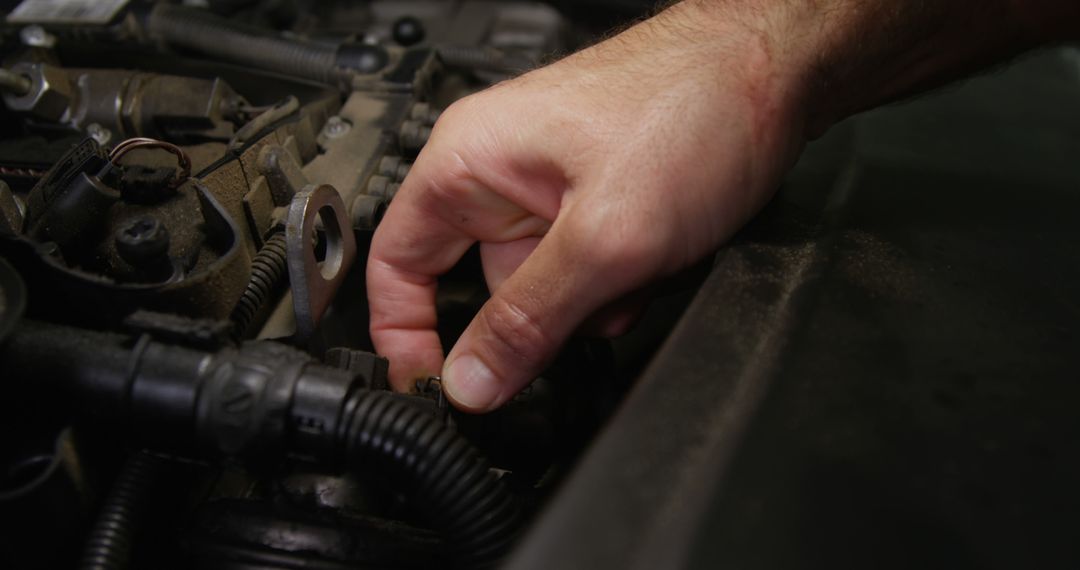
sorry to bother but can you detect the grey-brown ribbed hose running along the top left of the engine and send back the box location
[146,3,341,83]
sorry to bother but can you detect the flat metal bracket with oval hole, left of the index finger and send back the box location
[285,185,356,341]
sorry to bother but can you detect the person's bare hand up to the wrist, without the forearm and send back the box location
[367,3,804,411]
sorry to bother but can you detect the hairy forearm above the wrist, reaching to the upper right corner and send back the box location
[669,0,1080,136]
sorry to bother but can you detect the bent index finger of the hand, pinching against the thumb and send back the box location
[367,144,553,390]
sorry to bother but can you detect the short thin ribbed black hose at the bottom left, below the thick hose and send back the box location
[79,451,158,570]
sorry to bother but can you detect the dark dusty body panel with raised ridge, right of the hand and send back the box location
[509,51,1080,570]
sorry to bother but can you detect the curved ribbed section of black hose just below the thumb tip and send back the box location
[339,390,521,568]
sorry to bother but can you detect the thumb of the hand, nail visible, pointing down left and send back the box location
[443,215,622,412]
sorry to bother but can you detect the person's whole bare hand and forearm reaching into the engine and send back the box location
[367,0,1080,412]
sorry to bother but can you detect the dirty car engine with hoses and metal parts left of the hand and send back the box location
[0,0,656,570]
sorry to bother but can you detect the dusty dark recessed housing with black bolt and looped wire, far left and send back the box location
[0,139,249,321]
